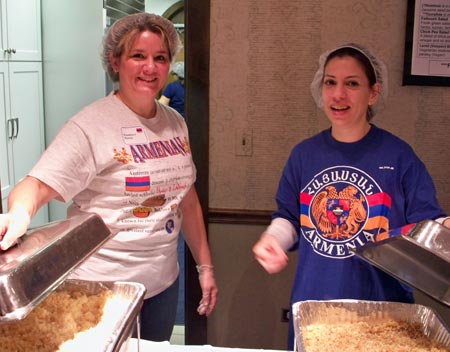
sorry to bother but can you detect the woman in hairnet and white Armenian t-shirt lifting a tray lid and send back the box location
[0,13,218,341]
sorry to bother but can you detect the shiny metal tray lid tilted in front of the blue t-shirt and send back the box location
[352,220,450,306]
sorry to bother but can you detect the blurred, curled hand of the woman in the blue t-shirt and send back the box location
[253,234,289,274]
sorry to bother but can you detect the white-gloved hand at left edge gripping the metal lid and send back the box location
[0,207,31,250]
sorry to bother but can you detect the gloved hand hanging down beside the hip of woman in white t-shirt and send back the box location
[197,265,218,317]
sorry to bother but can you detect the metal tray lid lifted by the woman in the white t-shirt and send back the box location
[0,214,111,323]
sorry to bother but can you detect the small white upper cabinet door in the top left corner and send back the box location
[0,0,42,61]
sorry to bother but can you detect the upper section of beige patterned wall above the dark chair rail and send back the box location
[209,0,450,212]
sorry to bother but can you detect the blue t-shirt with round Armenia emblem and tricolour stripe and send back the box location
[273,125,445,349]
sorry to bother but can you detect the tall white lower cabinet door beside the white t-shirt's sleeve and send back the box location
[0,62,48,226]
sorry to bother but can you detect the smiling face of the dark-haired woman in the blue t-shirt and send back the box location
[322,56,379,127]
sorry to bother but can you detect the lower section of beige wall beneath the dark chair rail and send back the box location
[208,224,295,350]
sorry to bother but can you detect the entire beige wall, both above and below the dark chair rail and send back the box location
[208,0,450,349]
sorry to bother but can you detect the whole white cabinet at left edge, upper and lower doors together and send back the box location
[0,0,48,226]
